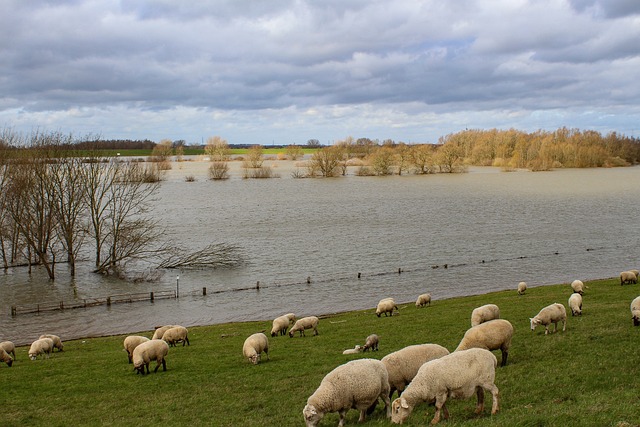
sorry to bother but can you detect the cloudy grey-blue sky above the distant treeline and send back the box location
[0,0,640,145]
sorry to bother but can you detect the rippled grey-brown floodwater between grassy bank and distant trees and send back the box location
[0,160,640,344]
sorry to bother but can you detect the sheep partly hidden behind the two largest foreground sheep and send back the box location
[382,344,449,398]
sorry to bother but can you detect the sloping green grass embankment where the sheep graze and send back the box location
[0,279,640,427]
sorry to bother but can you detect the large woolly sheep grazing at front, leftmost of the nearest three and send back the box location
[302,359,391,427]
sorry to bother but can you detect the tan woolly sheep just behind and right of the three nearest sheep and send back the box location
[455,319,513,366]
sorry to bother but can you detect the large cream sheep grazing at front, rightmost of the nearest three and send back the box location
[391,348,499,424]
